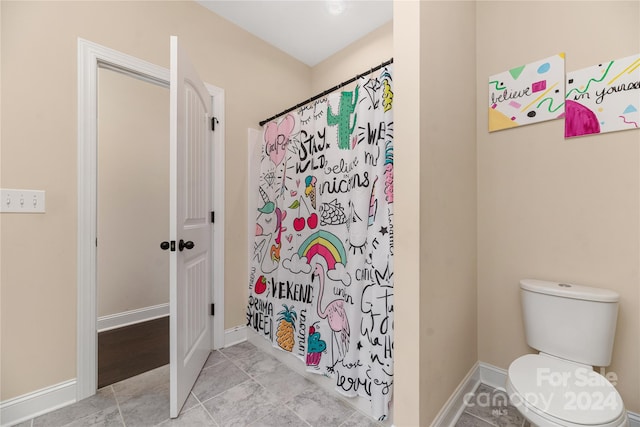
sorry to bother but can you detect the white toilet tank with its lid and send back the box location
[520,279,619,366]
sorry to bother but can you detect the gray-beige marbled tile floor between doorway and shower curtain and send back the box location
[19,342,380,427]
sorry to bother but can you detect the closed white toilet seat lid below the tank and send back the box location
[507,354,627,427]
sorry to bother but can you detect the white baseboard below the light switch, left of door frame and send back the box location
[0,379,76,427]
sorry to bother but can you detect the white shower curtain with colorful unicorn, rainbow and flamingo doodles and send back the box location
[247,67,393,419]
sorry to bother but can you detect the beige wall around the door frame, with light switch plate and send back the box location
[0,1,310,400]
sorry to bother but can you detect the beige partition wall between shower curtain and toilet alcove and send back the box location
[394,1,477,426]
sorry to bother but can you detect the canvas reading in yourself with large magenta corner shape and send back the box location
[564,55,640,138]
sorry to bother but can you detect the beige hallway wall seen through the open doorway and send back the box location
[96,68,169,317]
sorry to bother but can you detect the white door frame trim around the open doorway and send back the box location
[76,38,225,401]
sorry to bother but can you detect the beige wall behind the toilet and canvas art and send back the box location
[476,1,640,412]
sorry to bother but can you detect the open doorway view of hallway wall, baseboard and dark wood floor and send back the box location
[96,67,169,388]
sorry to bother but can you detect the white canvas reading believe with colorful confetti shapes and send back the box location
[489,53,565,132]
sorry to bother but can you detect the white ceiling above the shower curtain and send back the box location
[196,0,393,67]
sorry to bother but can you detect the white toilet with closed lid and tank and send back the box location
[506,279,629,427]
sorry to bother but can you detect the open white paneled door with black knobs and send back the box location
[169,37,212,418]
